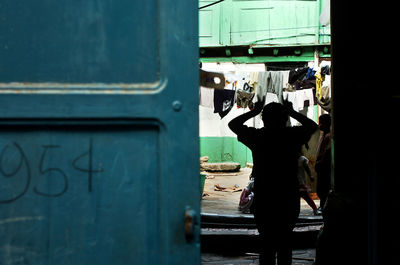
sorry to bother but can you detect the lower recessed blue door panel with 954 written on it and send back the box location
[0,123,163,264]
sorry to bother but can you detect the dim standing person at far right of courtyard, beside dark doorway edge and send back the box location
[315,114,332,211]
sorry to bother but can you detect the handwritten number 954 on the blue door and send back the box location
[0,139,103,204]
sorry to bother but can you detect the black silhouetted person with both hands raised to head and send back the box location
[229,101,318,265]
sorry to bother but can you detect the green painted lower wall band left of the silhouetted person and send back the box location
[200,137,253,167]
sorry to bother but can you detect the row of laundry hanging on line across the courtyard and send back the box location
[199,66,330,119]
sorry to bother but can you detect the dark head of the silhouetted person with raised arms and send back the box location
[262,102,289,128]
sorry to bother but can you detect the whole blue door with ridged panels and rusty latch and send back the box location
[0,0,200,265]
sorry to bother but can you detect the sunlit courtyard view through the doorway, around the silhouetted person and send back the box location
[199,0,332,258]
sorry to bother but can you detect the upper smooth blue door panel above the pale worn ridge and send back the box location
[0,0,160,83]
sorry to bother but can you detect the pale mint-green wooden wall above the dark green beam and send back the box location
[200,0,330,47]
